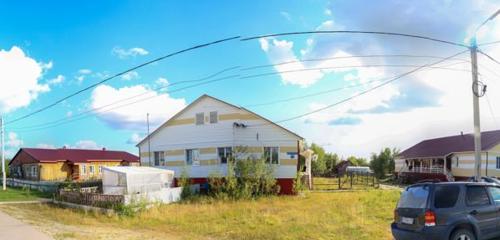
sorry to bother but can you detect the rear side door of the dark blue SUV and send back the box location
[465,185,498,238]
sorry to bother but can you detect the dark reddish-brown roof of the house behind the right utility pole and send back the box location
[398,130,500,158]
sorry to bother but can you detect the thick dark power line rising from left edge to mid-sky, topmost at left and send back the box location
[5,36,240,124]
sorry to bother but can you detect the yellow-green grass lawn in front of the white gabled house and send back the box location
[0,190,399,239]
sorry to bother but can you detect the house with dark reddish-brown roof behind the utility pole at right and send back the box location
[395,130,500,181]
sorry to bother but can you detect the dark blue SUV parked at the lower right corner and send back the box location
[391,182,500,240]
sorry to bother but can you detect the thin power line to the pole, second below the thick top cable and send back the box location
[241,54,470,71]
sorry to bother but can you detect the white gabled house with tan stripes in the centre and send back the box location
[137,95,303,194]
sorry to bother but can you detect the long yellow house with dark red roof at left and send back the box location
[9,148,139,181]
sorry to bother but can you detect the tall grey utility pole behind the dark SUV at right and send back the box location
[470,37,482,182]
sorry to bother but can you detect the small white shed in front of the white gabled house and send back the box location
[102,166,174,195]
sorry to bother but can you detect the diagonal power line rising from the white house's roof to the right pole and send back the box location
[249,50,469,127]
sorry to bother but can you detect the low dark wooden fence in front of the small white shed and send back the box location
[58,189,125,208]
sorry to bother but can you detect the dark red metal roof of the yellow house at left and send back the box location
[16,148,139,163]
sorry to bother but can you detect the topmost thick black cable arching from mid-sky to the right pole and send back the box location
[241,30,469,49]
